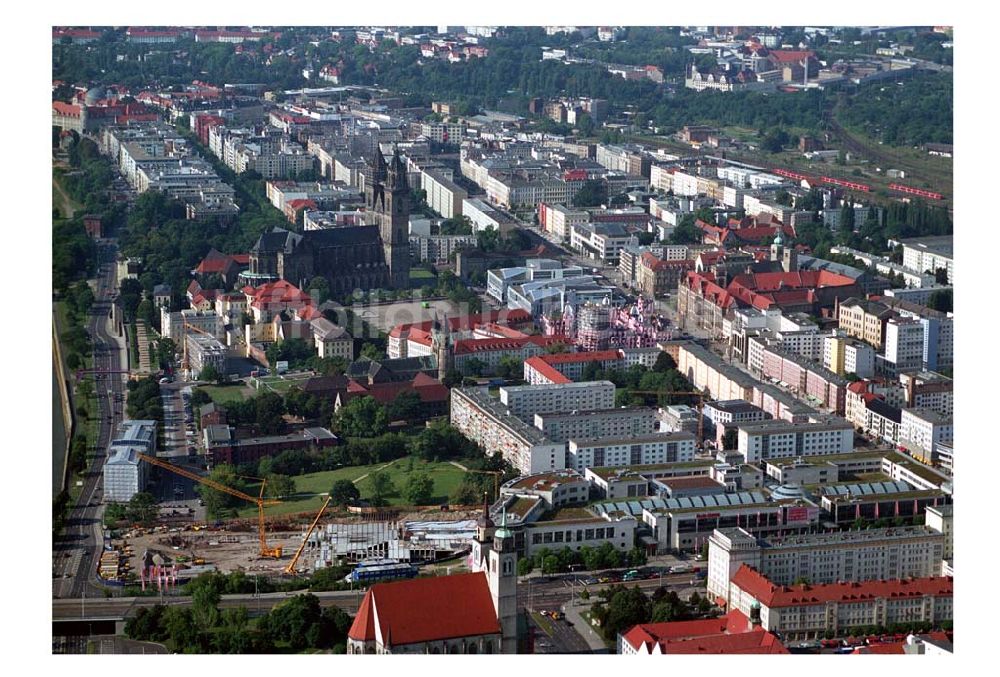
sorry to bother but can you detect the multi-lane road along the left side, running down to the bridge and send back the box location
[52,240,127,598]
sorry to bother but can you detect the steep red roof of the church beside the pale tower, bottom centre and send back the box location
[347,572,500,646]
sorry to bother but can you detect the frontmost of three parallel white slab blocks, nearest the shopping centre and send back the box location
[566,432,695,472]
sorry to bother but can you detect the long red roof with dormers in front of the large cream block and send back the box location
[732,564,952,608]
